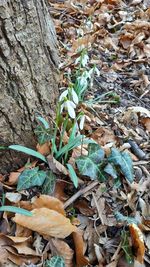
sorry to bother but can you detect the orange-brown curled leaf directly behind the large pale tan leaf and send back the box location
[32,195,65,216]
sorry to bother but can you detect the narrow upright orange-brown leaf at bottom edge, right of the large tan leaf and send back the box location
[73,230,89,267]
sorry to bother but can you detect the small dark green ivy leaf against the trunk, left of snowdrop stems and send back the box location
[34,125,53,145]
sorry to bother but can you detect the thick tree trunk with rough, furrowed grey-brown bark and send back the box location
[0,0,58,173]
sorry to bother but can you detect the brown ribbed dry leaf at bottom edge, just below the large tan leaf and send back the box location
[50,238,74,267]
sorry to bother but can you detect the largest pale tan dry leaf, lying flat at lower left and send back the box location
[13,208,77,238]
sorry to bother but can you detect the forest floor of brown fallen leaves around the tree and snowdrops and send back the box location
[0,0,150,267]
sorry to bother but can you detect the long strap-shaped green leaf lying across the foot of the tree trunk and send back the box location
[8,145,47,163]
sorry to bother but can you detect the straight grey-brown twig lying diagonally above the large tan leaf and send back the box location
[64,181,99,209]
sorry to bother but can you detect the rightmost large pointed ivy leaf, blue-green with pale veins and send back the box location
[108,148,133,183]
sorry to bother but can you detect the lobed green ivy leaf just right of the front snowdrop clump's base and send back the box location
[76,144,105,181]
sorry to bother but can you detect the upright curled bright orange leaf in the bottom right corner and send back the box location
[129,223,145,264]
